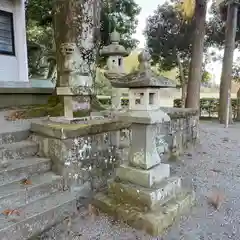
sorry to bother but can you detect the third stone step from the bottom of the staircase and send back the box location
[0,157,51,186]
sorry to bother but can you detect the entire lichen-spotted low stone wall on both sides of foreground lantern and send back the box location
[31,108,198,195]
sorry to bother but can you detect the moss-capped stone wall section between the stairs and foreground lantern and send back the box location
[31,119,130,194]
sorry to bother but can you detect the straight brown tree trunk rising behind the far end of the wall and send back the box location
[186,0,207,109]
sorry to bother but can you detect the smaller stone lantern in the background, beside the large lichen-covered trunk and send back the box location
[100,30,129,111]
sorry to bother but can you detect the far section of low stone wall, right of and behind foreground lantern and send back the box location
[120,107,199,160]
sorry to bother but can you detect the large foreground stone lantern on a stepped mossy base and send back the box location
[94,51,194,236]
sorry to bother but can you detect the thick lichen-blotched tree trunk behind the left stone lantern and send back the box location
[54,0,102,94]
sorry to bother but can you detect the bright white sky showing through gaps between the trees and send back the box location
[134,0,226,83]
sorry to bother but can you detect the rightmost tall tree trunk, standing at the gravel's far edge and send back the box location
[219,4,238,123]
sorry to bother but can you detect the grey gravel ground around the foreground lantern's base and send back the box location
[42,123,240,240]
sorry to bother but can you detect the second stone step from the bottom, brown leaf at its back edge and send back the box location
[0,172,63,212]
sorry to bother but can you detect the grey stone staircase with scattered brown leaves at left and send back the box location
[0,130,76,240]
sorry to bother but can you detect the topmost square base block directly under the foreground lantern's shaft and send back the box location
[116,164,170,188]
